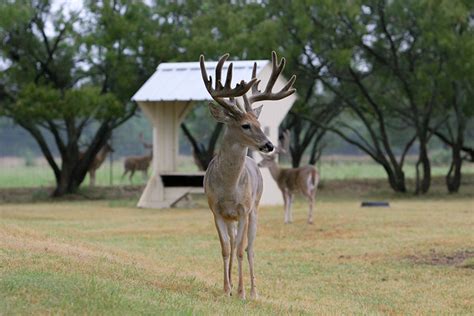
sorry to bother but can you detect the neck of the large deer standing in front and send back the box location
[216,129,248,188]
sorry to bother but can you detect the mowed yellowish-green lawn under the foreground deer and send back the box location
[0,197,474,315]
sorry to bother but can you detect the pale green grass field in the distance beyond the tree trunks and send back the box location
[0,156,474,188]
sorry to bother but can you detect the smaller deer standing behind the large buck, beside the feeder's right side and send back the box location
[258,131,319,224]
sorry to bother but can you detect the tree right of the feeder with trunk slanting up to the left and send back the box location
[270,2,414,192]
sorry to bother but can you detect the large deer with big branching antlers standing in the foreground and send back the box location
[200,52,296,299]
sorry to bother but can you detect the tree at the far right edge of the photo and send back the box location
[430,2,474,193]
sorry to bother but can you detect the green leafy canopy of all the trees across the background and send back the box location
[0,0,474,194]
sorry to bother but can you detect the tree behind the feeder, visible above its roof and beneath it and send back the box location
[168,1,284,170]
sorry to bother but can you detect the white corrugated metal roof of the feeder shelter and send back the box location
[132,60,270,101]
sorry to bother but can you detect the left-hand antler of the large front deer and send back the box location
[199,54,257,115]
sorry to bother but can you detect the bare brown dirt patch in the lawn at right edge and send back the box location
[407,249,474,269]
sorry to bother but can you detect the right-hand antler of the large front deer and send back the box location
[244,51,296,112]
